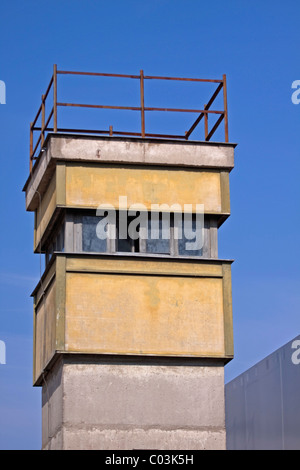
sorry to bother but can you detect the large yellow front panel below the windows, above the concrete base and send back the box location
[66,273,224,357]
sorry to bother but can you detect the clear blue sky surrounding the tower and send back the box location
[0,0,300,449]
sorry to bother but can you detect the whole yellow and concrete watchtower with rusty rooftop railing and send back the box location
[24,66,235,450]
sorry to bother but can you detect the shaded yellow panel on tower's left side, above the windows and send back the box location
[34,174,56,250]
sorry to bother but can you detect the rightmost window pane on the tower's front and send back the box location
[178,218,203,256]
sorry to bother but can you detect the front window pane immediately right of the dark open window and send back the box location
[146,217,170,254]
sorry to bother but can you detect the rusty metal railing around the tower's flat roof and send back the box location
[30,65,228,172]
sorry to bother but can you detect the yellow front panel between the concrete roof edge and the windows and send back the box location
[66,164,222,213]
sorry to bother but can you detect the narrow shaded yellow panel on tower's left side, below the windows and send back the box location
[35,280,56,378]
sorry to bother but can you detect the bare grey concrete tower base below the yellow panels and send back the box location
[42,355,226,450]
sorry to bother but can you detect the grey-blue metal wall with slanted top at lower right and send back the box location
[225,336,300,450]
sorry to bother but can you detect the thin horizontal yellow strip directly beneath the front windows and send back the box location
[66,256,223,277]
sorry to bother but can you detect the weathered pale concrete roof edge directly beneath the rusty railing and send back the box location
[24,134,236,211]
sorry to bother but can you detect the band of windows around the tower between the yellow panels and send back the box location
[46,211,211,264]
